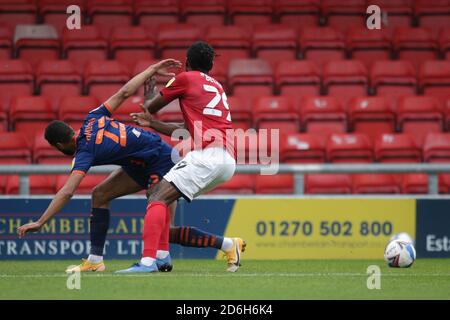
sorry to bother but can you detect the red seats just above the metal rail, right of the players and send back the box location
[236,133,450,164]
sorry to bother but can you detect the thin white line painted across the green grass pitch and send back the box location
[0,272,450,280]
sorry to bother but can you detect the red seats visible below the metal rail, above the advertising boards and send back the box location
[0,173,450,195]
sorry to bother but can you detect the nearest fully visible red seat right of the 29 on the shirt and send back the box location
[253,96,300,133]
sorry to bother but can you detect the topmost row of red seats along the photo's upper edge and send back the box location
[0,0,450,29]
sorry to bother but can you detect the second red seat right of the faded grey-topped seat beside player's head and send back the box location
[323,60,369,100]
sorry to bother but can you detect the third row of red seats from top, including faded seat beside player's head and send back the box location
[0,59,450,108]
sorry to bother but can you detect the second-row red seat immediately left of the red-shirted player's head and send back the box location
[157,23,203,61]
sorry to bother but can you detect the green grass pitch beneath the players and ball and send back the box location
[0,259,450,299]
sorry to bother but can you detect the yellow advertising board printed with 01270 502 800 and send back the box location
[221,198,416,259]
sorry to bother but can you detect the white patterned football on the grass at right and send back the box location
[384,240,416,268]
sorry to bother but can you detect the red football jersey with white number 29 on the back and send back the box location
[161,71,236,157]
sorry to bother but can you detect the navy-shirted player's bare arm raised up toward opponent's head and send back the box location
[106,59,181,112]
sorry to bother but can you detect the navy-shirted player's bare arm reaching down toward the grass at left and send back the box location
[17,173,84,238]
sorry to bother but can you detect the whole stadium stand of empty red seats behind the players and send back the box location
[0,0,450,194]
